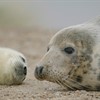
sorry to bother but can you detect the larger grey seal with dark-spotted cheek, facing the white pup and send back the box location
[35,17,100,90]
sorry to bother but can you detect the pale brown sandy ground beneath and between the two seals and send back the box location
[0,29,100,100]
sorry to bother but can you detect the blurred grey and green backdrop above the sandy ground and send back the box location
[0,0,100,30]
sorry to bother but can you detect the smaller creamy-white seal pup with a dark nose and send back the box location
[0,48,27,85]
